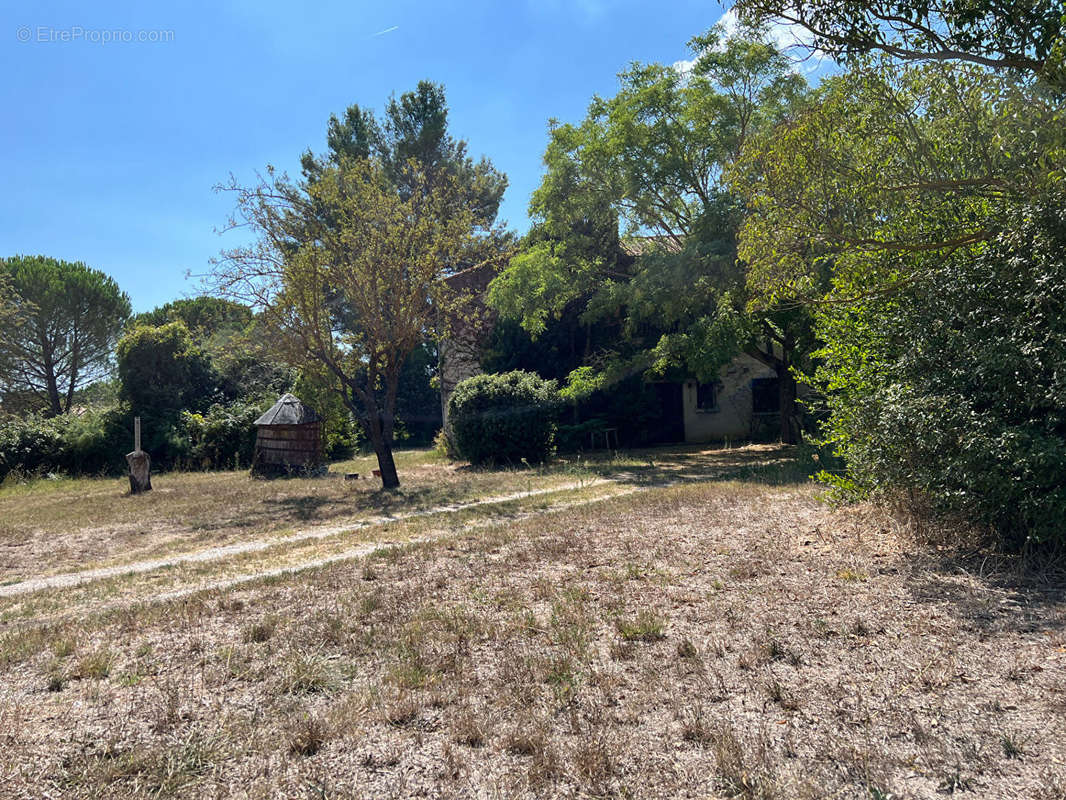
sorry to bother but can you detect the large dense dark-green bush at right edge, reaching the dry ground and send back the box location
[819,193,1066,546]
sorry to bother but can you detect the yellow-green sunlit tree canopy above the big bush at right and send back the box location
[731,62,1066,302]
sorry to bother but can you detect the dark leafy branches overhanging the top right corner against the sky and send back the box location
[736,0,1066,85]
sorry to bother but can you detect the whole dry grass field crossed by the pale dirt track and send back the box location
[0,447,1066,800]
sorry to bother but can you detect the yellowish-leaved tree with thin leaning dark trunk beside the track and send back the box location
[206,156,488,489]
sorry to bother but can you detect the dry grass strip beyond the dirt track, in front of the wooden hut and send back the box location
[0,450,591,583]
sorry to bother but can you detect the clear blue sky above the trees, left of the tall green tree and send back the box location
[0,0,724,310]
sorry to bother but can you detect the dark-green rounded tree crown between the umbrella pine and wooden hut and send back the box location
[117,322,220,417]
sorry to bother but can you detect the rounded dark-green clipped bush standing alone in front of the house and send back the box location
[448,371,560,464]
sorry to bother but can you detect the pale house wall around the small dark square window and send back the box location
[681,354,777,442]
